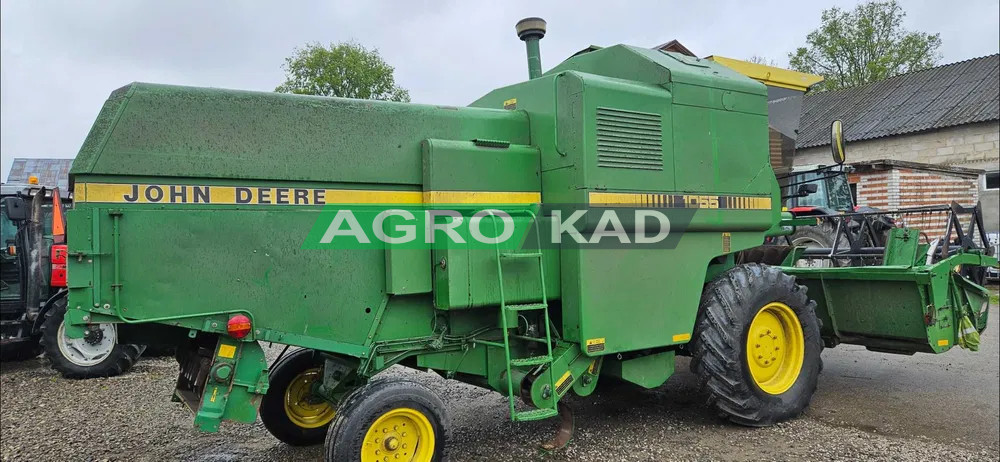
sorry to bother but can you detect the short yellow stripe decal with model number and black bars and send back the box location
[588,192,771,210]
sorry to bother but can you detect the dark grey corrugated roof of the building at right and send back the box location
[795,54,1000,149]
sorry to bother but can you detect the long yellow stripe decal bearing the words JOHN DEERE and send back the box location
[74,183,542,205]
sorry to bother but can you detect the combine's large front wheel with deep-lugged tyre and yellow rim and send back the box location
[691,264,823,426]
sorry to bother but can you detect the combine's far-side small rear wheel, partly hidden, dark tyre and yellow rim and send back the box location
[260,349,337,446]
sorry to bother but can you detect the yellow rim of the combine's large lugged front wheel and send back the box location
[747,302,805,395]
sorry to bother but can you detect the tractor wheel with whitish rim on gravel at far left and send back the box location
[42,298,144,379]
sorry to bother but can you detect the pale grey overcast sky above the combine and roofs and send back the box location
[0,0,1000,180]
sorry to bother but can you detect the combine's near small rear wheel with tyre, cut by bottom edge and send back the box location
[326,379,450,462]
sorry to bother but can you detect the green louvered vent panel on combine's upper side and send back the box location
[597,107,663,170]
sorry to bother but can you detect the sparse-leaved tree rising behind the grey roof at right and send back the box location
[788,0,941,90]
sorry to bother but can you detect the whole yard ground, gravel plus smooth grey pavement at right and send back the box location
[0,286,1000,462]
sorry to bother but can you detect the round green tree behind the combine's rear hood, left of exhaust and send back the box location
[274,42,410,102]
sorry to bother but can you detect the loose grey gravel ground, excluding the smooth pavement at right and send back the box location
[0,352,998,462]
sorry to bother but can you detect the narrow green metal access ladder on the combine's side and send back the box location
[482,210,559,421]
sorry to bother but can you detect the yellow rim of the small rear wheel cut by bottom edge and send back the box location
[361,408,434,462]
